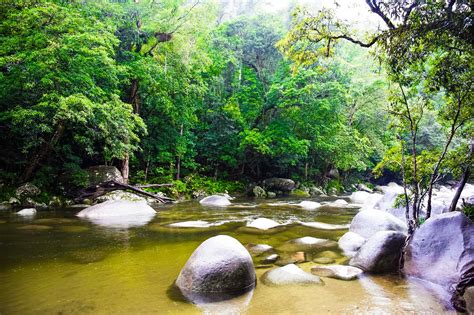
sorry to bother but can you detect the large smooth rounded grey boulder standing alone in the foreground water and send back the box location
[176,235,256,304]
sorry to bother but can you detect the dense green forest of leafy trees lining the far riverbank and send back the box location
[0,0,474,212]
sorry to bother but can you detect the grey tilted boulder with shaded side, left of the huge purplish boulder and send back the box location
[349,231,406,273]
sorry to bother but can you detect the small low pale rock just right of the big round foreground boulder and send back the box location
[262,264,324,286]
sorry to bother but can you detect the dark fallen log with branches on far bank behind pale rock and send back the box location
[74,180,175,203]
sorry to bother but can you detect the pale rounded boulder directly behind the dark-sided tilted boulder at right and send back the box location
[349,210,407,238]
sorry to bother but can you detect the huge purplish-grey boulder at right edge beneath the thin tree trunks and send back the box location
[403,211,474,294]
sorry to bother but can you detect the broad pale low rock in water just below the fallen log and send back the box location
[77,200,156,218]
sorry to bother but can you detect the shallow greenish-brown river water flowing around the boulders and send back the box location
[0,199,452,315]
